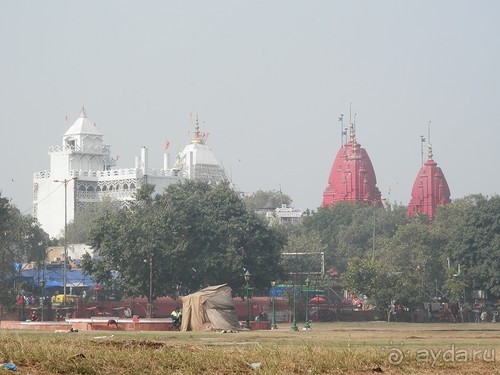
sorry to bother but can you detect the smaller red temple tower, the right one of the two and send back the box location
[406,145,451,220]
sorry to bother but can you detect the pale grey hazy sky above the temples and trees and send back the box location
[0,0,500,213]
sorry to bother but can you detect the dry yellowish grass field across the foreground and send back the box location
[0,322,500,375]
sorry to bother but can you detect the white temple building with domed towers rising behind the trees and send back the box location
[33,108,228,237]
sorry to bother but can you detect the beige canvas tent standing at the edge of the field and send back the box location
[181,284,240,331]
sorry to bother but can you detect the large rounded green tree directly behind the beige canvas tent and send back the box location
[82,181,284,306]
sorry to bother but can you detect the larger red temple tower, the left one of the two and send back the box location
[321,124,382,207]
